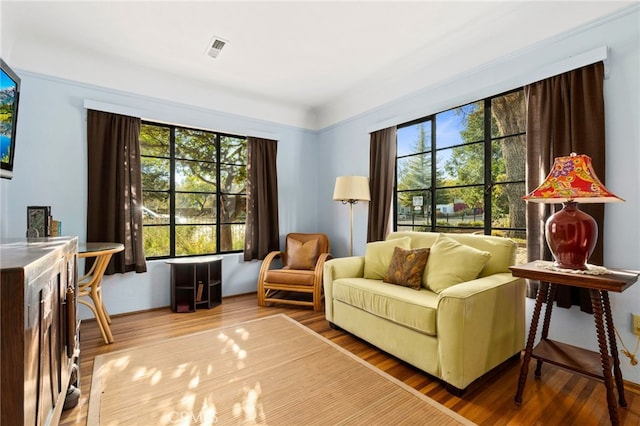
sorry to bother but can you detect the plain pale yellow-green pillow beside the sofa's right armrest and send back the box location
[426,234,491,293]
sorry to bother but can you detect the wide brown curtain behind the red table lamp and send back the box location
[525,62,605,312]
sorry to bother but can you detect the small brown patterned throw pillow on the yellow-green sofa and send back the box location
[383,247,429,290]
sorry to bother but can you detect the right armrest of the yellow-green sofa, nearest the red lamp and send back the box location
[436,273,525,389]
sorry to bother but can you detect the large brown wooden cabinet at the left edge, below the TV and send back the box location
[0,237,79,425]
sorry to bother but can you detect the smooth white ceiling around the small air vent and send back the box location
[0,0,638,128]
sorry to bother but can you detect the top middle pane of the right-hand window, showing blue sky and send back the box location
[436,102,484,149]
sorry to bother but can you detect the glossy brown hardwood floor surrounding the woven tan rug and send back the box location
[60,294,640,425]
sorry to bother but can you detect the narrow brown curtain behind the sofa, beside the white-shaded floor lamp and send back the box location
[367,126,396,242]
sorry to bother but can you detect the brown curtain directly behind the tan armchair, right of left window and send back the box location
[244,137,280,261]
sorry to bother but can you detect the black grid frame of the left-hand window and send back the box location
[141,120,248,260]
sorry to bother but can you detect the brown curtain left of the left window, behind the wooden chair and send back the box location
[86,110,147,274]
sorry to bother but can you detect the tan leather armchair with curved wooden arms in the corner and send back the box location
[258,233,331,311]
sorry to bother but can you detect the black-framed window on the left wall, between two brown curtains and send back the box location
[140,122,247,258]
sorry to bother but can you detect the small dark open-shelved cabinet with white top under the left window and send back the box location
[166,256,222,312]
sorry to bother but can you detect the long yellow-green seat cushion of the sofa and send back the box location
[333,278,438,336]
